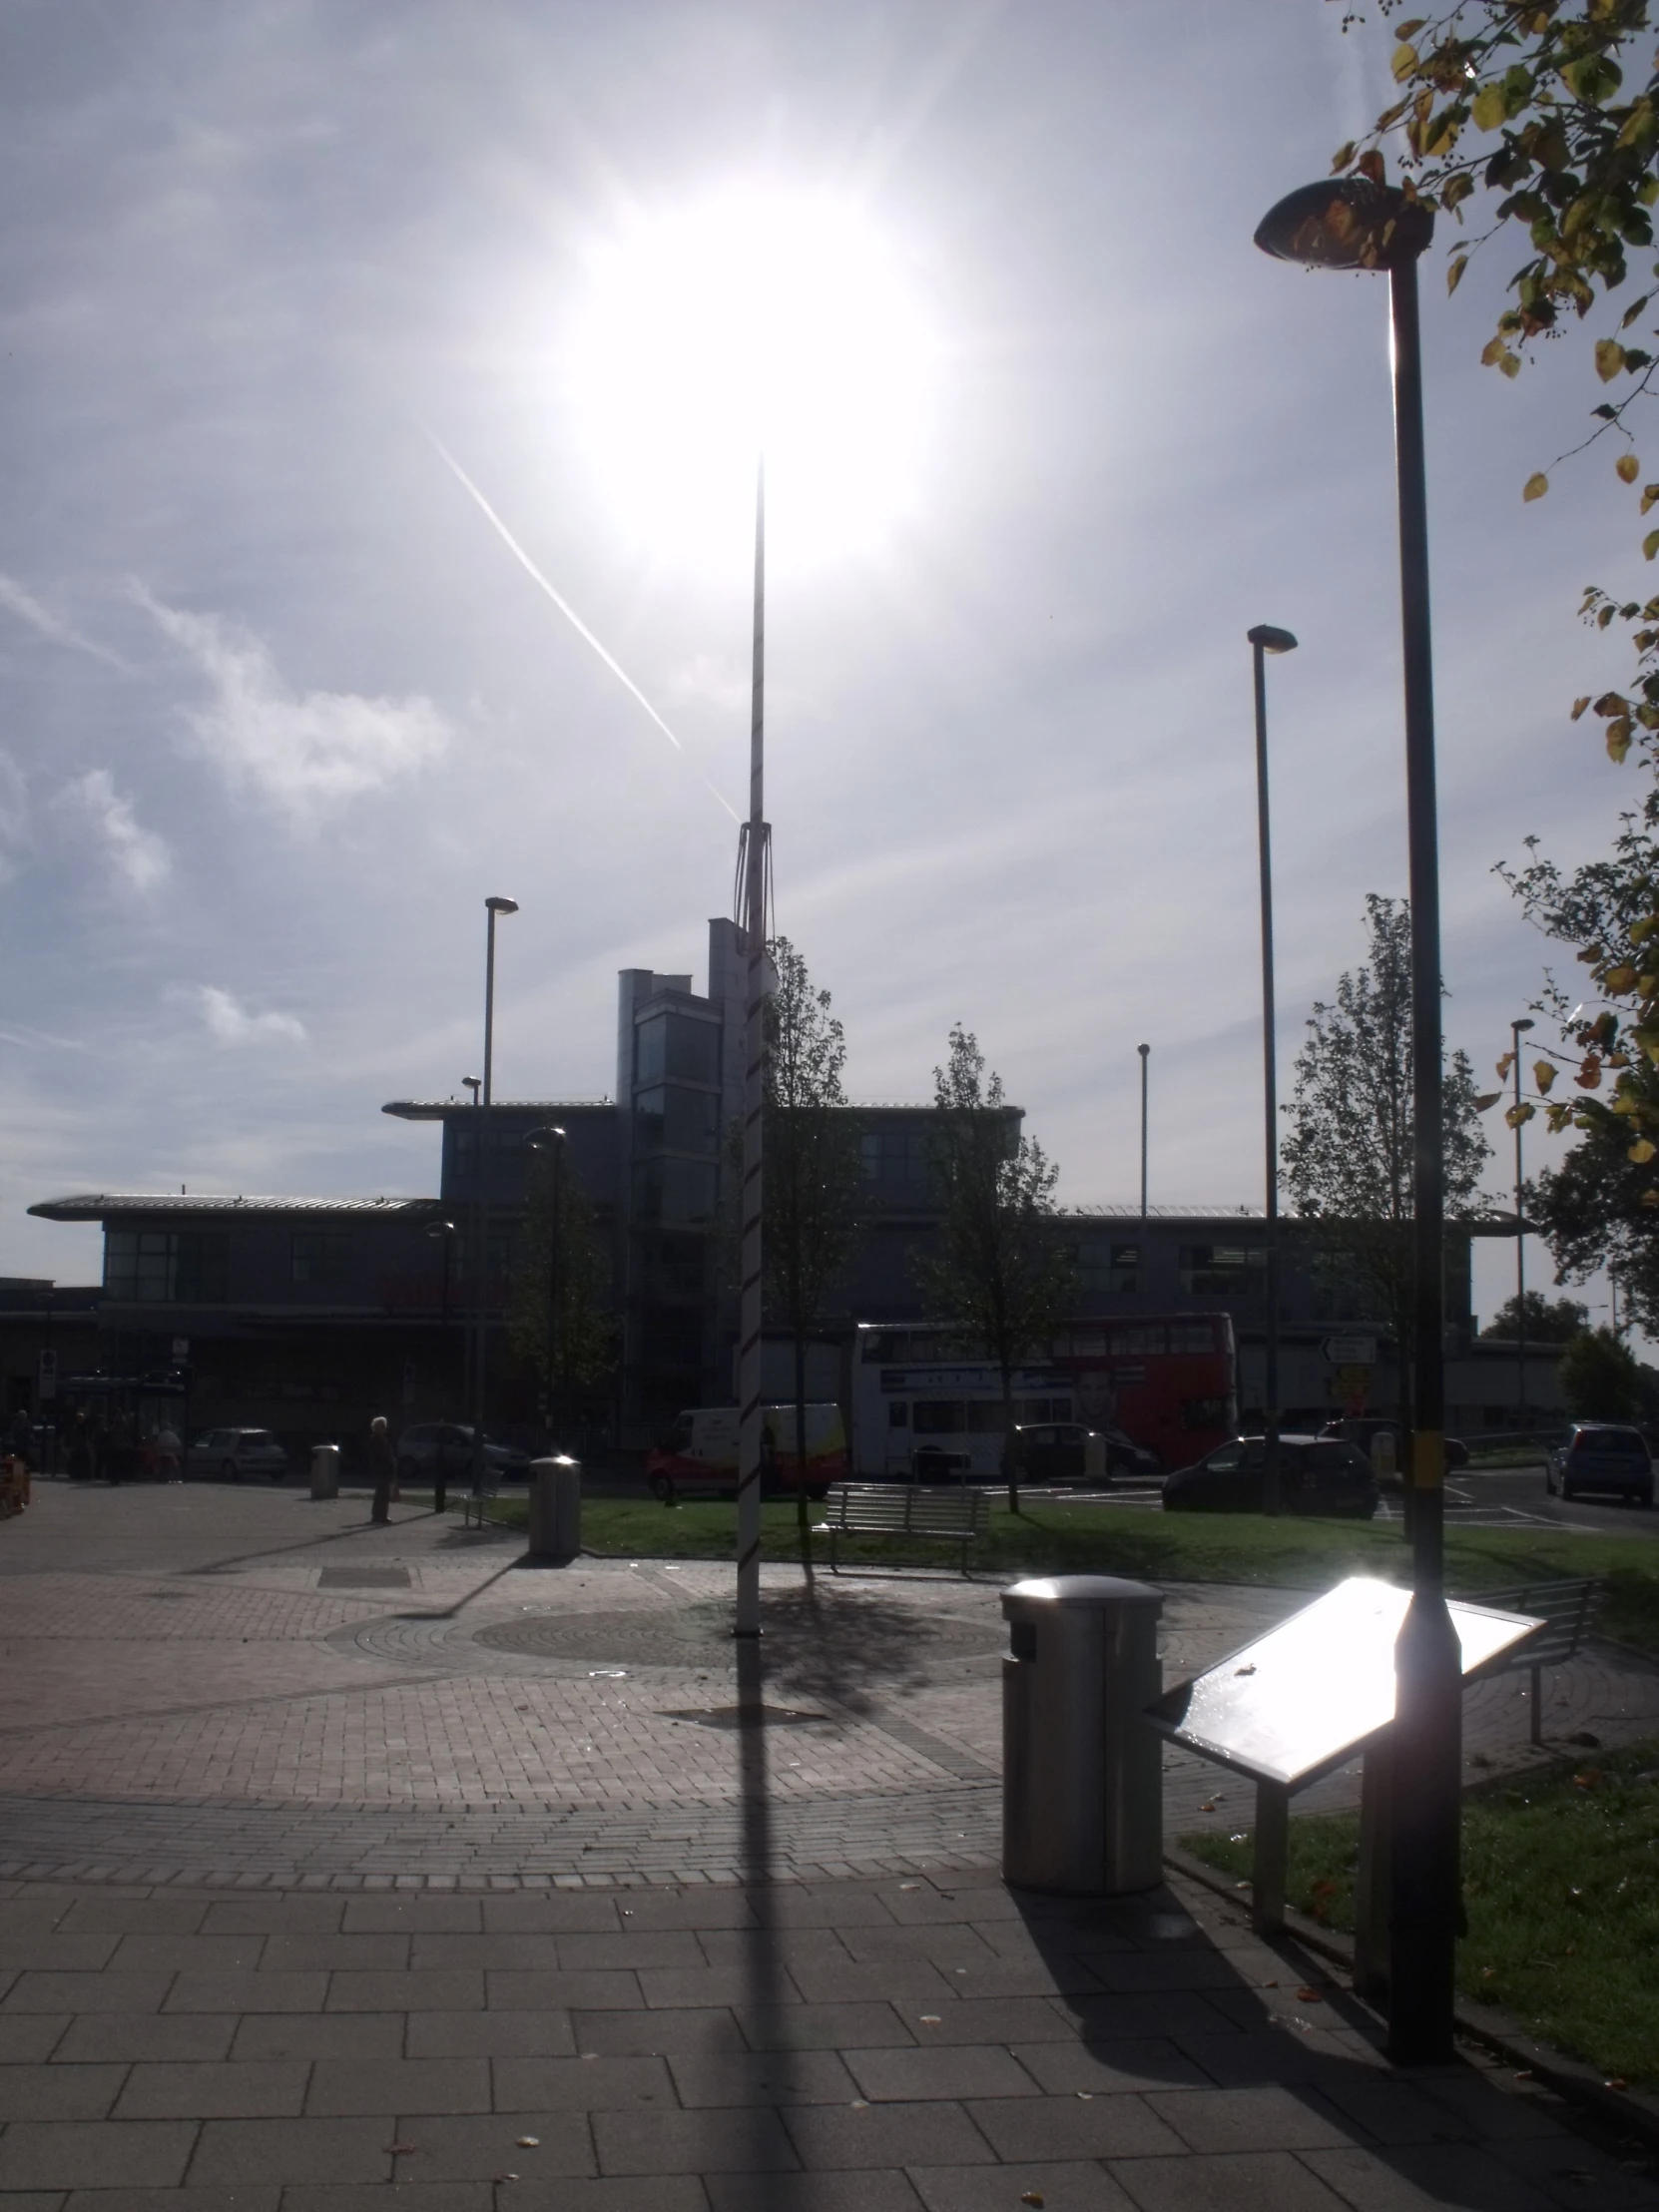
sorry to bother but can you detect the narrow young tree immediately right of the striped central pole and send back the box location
[761,938,860,1570]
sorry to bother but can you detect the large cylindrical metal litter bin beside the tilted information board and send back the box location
[1002,1575,1164,1898]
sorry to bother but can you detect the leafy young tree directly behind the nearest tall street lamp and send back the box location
[1281,891,1491,1404]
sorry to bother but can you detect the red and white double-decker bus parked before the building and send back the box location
[851,1314,1239,1482]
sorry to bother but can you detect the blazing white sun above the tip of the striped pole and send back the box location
[566,191,935,560]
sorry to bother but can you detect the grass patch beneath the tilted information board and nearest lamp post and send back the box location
[1181,1743,1659,2086]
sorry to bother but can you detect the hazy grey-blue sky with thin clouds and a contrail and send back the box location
[0,0,1643,1319]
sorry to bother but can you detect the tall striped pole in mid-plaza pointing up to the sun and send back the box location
[737,458,766,1637]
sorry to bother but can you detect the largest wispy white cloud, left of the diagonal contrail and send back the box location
[133,584,451,819]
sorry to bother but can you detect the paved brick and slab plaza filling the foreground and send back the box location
[0,1484,1659,2212]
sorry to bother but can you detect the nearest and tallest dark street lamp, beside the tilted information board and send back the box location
[1257,177,1462,2064]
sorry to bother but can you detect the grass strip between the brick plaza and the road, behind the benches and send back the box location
[435,1493,1659,1655]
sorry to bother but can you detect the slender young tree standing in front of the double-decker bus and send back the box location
[915,1022,1077,1513]
